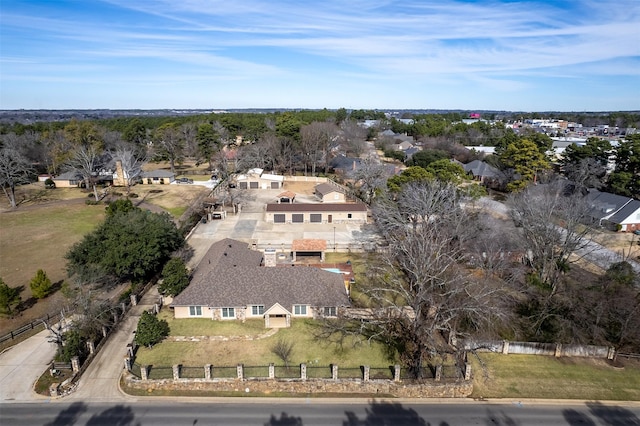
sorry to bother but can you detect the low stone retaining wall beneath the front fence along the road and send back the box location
[125,374,473,398]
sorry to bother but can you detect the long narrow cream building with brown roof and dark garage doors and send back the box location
[265,203,367,223]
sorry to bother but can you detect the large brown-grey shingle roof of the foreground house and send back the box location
[172,239,349,310]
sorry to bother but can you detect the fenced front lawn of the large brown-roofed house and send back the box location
[136,311,392,367]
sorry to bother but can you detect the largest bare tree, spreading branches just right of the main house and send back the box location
[322,181,502,378]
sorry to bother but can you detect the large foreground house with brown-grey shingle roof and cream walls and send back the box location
[170,238,349,328]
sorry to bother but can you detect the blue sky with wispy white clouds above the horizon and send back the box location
[0,0,640,111]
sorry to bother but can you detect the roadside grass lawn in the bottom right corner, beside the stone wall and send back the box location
[469,353,640,401]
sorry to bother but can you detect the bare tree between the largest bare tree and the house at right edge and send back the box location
[508,181,591,295]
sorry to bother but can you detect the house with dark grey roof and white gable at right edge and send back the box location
[587,190,640,232]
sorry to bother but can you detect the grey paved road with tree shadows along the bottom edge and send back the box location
[2,399,640,426]
